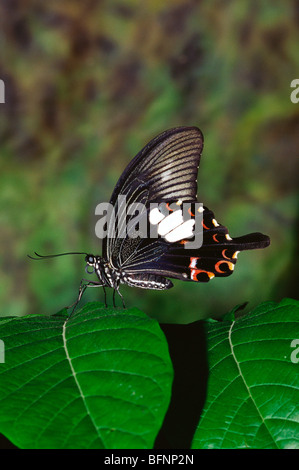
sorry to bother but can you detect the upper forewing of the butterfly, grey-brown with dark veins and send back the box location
[103,127,203,268]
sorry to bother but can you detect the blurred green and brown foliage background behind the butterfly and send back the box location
[0,0,299,322]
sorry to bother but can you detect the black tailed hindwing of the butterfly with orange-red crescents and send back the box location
[119,207,270,282]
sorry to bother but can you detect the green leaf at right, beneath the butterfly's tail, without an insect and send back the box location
[193,299,299,449]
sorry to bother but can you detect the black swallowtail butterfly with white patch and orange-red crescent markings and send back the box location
[28,127,270,305]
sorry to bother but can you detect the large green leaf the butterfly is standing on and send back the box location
[0,302,172,449]
